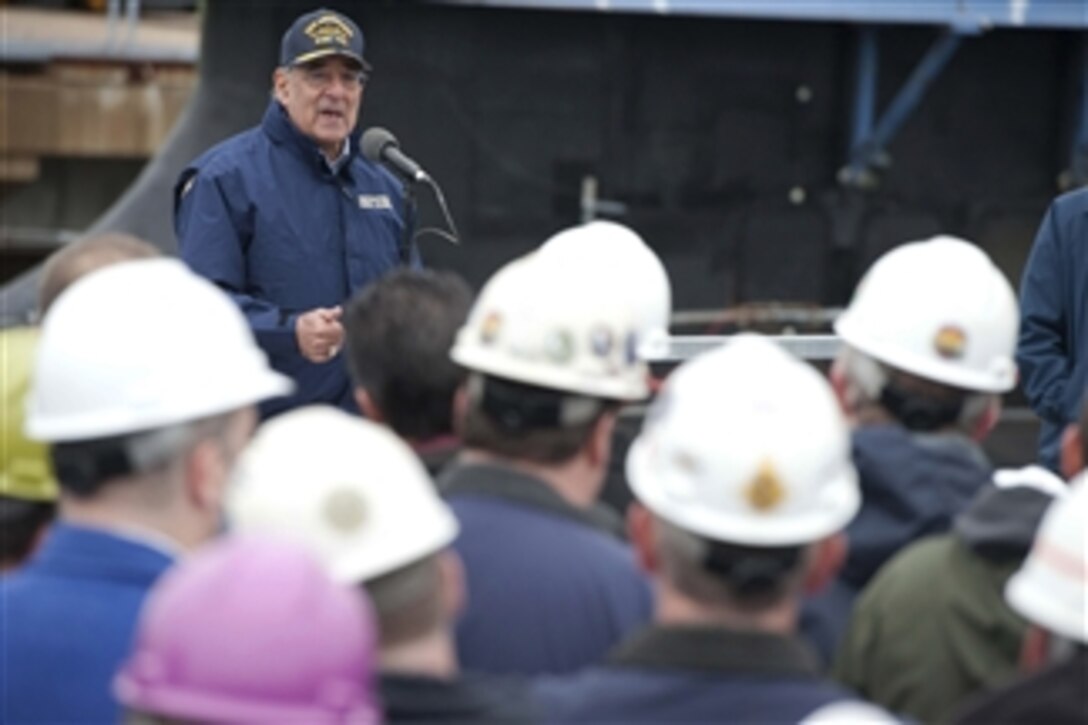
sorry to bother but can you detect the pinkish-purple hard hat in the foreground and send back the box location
[113,538,381,725]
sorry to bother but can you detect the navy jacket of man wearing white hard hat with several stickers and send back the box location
[438,464,653,675]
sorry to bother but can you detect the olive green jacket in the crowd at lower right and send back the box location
[834,533,1026,723]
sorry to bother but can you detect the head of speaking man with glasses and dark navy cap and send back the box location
[272,9,371,157]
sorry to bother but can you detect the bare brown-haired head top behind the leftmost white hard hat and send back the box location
[38,232,162,319]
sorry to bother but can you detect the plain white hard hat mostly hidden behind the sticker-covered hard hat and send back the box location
[540,221,672,358]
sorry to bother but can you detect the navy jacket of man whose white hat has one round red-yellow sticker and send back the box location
[802,423,993,662]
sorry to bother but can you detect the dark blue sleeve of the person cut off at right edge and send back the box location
[1016,205,1073,423]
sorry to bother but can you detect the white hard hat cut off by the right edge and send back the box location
[1005,474,1088,643]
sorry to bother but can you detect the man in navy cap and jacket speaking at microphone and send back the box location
[174,9,419,418]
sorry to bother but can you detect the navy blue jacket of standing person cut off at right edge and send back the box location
[1016,189,1088,471]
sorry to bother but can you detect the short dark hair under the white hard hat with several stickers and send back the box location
[461,374,619,465]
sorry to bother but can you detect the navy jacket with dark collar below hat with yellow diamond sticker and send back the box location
[534,626,888,725]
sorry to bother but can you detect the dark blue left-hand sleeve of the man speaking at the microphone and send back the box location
[174,171,300,355]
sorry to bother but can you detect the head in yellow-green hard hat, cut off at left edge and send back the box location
[0,328,57,572]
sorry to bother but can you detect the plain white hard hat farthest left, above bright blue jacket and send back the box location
[26,259,294,443]
